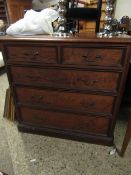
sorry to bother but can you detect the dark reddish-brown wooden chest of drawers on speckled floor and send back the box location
[0,34,131,145]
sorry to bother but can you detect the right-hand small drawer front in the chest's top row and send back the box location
[62,47,124,67]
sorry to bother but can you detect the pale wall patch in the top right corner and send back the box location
[115,0,131,20]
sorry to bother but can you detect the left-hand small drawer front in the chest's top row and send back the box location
[6,46,57,63]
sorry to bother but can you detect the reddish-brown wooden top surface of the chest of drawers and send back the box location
[0,33,131,44]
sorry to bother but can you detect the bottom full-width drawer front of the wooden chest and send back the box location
[20,107,110,135]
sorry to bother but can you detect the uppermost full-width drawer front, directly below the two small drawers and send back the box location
[11,67,120,92]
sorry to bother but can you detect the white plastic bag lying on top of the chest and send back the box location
[6,8,59,35]
